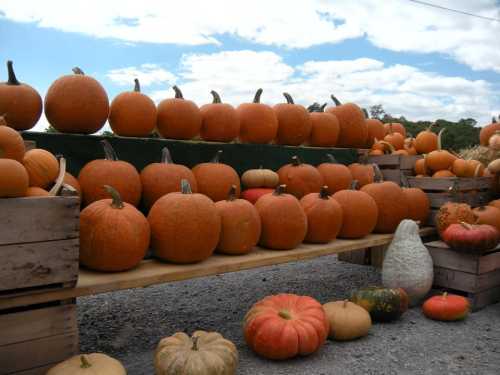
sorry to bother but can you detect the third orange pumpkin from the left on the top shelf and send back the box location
[109,78,156,137]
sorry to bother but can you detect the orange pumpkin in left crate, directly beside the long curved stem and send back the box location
[23,148,59,188]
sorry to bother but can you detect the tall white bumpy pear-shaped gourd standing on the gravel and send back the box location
[382,220,434,306]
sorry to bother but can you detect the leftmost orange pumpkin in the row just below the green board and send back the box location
[78,140,142,206]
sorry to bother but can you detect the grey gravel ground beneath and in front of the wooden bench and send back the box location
[78,256,500,375]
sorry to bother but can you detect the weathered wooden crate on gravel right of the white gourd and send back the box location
[425,241,500,311]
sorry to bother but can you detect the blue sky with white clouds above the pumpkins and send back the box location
[0,0,500,129]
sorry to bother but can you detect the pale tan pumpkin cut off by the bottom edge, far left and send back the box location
[46,353,127,375]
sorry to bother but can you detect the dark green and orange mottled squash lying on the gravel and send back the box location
[350,286,408,322]
